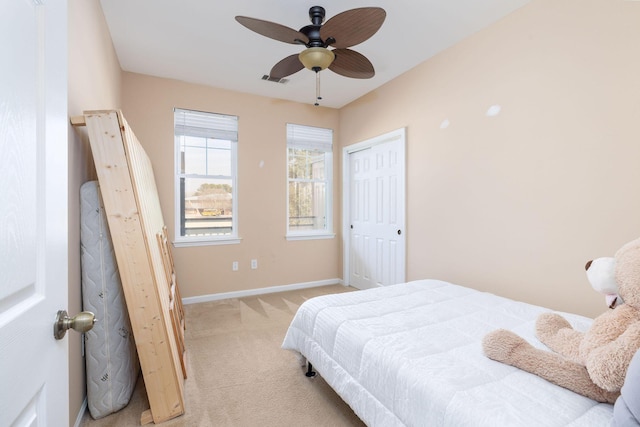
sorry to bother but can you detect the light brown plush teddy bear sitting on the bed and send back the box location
[482,239,640,403]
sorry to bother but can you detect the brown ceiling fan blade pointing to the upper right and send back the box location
[320,7,387,49]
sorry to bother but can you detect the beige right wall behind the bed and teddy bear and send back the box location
[339,0,640,316]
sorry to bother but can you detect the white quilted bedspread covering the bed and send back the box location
[282,280,613,427]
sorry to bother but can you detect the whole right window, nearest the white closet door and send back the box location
[287,124,333,239]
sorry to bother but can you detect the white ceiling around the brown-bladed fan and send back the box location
[101,0,529,108]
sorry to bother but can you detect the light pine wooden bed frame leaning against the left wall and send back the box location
[71,110,187,425]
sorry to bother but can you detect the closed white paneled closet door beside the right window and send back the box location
[343,129,405,289]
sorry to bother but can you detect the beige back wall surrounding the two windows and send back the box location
[123,73,340,297]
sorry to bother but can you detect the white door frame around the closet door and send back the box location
[342,127,407,286]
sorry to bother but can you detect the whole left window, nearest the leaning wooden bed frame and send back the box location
[174,109,239,246]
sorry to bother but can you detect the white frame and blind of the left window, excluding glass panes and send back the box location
[174,108,241,247]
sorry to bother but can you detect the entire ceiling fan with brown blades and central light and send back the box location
[236,6,387,105]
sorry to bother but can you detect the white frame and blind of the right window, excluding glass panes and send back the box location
[286,123,335,240]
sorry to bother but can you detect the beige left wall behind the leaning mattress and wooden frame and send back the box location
[67,0,121,424]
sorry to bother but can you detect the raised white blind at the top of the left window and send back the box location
[173,108,238,142]
